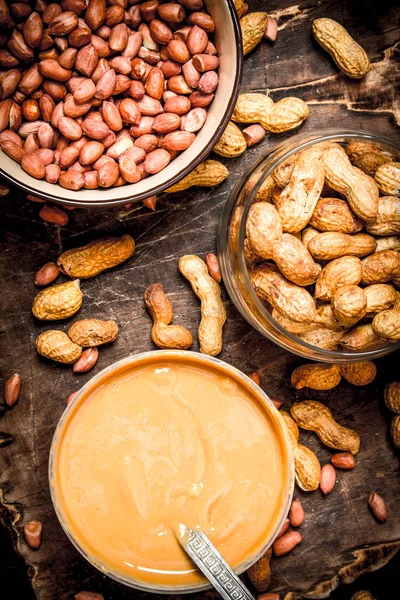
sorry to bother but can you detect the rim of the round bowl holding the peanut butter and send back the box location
[48,350,295,594]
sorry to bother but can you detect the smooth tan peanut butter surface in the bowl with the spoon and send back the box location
[52,356,289,586]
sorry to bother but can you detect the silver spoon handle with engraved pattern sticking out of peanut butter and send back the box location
[175,524,255,600]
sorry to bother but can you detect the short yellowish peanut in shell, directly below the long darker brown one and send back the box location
[32,279,83,321]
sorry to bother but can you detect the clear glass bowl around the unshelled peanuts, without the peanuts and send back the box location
[218,129,400,363]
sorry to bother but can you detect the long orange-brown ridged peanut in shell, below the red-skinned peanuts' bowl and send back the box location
[57,235,135,279]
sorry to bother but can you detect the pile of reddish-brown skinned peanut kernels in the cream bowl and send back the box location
[0,0,219,190]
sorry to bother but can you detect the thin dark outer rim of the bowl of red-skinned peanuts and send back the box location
[0,0,243,209]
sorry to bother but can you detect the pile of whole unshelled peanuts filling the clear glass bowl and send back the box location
[244,140,400,352]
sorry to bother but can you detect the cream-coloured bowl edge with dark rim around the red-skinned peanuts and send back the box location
[0,0,243,208]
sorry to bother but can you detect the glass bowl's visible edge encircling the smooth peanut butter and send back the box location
[49,350,294,594]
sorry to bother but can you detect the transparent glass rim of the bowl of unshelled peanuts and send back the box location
[217,128,400,363]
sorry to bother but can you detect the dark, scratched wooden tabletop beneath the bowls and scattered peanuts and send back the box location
[0,0,400,600]
